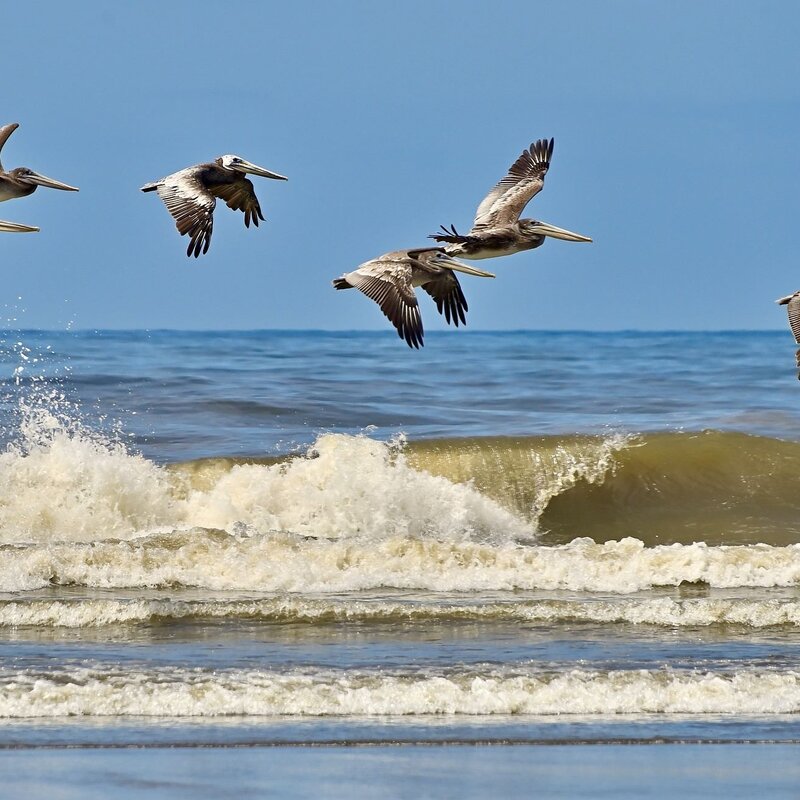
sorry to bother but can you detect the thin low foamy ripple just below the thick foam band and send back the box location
[0,595,800,628]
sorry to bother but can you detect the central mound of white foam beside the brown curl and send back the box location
[184,434,532,541]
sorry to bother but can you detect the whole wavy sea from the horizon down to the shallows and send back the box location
[0,331,800,798]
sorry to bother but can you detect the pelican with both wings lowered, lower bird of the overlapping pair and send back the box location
[333,247,494,349]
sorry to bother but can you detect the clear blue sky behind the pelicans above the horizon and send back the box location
[0,0,800,330]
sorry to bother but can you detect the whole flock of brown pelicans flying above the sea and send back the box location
[0,123,800,362]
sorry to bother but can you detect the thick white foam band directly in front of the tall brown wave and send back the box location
[0,529,800,594]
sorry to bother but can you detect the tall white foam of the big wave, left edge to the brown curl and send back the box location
[0,428,532,543]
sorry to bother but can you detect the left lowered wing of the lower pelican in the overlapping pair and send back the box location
[345,259,424,349]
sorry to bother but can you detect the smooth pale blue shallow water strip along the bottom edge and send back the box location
[0,744,800,800]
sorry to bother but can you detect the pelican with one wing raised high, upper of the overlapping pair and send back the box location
[430,139,592,259]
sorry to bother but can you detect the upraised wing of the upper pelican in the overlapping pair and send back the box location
[472,139,553,231]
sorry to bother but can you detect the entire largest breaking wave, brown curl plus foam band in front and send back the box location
[0,408,800,593]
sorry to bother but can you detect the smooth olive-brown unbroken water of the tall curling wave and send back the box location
[172,431,800,546]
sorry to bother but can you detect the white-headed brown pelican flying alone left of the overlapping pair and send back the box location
[142,155,288,258]
